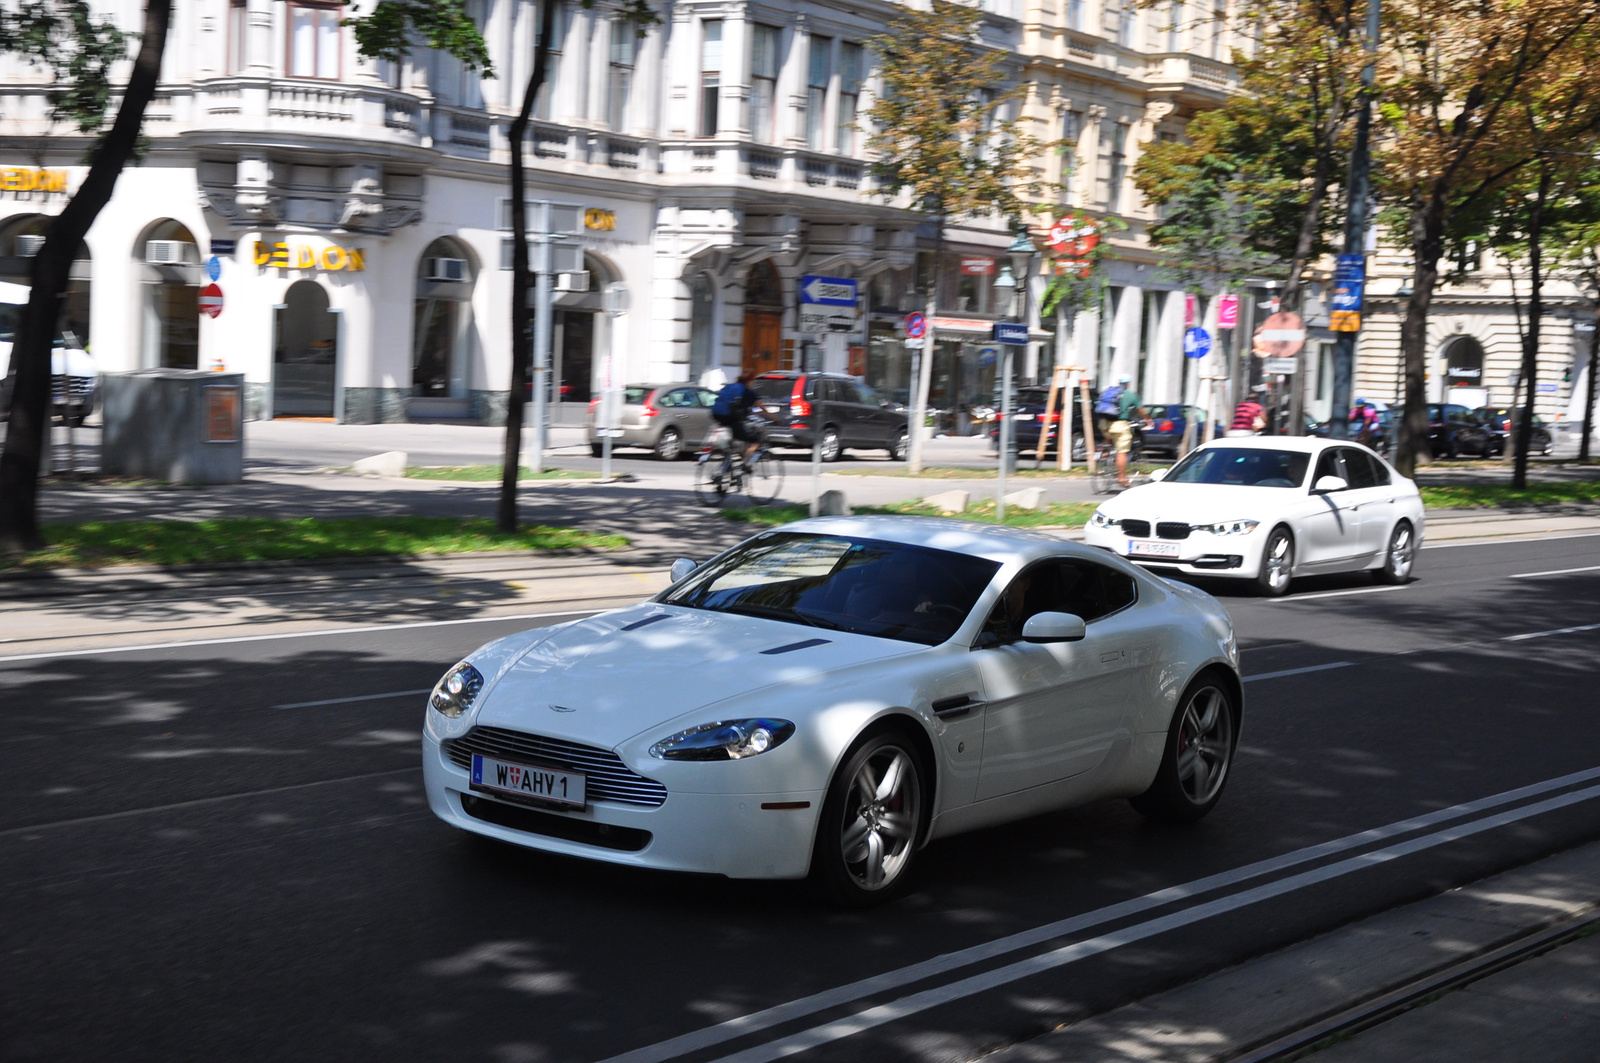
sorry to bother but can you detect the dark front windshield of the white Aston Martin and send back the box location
[661,532,1000,645]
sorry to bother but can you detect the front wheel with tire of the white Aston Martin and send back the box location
[811,732,928,908]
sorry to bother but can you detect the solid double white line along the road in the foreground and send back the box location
[603,767,1600,1063]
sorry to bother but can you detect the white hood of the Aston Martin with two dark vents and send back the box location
[475,602,925,748]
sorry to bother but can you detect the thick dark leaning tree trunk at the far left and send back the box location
[0,0,173,552]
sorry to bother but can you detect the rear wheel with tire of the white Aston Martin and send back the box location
[1131,674,1238,823]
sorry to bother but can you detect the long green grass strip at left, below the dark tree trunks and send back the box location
[0,517,629,570]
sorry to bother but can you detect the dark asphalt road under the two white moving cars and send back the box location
[0,536,1600,1063]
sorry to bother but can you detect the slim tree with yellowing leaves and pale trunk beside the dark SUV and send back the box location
[866,0,1043,475]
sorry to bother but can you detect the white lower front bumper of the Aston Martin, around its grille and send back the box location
[422,733,826,879]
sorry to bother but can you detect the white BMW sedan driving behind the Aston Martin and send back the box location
[1083,435,1426,596]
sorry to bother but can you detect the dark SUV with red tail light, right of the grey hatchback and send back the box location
[754,371,907,461]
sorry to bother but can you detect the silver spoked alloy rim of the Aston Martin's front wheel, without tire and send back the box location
[840,744,922,892]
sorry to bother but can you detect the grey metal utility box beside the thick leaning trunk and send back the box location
[101,370,245,483]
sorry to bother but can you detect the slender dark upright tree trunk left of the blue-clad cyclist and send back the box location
[494,0,555,533]
